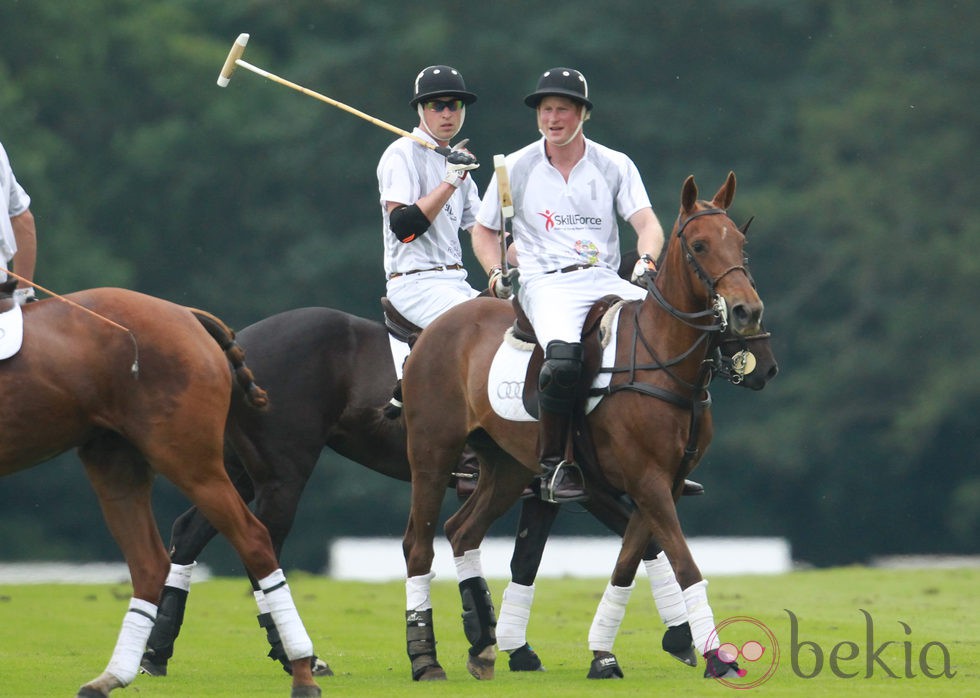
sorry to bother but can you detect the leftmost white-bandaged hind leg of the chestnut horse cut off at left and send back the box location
[79,434,168,696]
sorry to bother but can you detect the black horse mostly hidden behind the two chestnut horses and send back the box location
[141,278,778,676]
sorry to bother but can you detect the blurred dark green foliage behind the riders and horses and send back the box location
[0,0,980,573]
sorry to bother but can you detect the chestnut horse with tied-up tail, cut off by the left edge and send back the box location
[0,284,320,697]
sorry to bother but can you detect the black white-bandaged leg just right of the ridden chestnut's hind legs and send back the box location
[497,497,561,671]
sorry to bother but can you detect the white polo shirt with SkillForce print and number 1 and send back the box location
[476,138,650,277]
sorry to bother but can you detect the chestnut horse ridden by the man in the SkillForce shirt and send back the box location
[403,173,763,680]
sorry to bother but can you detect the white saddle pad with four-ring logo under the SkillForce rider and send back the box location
[487,303,622,422]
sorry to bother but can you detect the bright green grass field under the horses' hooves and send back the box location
[0,567,980,698]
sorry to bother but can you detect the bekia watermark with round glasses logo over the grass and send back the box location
[709,609,957,690]
